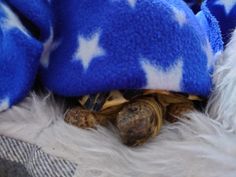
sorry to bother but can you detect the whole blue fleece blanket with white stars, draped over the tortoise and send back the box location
[0,0,233,110]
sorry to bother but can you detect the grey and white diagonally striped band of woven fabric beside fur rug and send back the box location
[0,136,77,177]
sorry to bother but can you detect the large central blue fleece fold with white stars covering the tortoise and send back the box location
[41,0,219,96]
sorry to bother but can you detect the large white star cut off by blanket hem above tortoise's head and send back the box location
[141,59,183,91]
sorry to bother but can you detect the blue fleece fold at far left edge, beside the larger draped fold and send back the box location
[0,1,42,111]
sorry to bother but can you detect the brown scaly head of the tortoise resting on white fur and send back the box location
[117,99,162,146]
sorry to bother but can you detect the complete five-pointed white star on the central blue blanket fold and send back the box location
[74,33,106,70]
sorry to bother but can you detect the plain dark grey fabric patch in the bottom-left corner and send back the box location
[0,158,31,177]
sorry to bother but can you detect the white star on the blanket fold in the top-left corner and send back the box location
[0,4,29,36]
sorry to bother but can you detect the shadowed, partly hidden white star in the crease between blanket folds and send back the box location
[40,28,61,68]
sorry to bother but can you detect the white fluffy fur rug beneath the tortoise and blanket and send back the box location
[0,31,236,177]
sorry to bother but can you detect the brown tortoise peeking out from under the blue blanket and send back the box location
[65,90,202,146]
